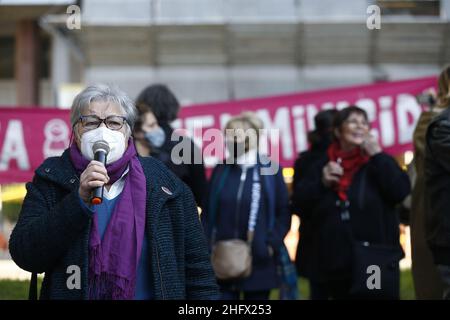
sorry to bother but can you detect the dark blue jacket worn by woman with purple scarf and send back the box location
[10,150,218,300]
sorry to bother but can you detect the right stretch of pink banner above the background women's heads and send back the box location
[176,77,437,167]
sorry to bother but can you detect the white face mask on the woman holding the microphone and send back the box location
[81,127,125,164]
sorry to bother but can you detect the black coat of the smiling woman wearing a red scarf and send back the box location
[293,153,410,282]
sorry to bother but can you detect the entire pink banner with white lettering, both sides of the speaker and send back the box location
[0,77,437,184]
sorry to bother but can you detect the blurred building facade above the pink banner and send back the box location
[0,0,450,106]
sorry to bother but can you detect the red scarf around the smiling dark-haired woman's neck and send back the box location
[328,142,369,201]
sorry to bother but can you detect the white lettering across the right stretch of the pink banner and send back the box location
[174,89,428,167]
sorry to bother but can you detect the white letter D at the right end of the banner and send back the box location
[397,94,422,144]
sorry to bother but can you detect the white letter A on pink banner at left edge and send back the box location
[0,119,30,171]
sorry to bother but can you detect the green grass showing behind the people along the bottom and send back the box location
[0,270,414,300]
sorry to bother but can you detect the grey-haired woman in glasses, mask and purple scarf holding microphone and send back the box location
[10,85,218,300]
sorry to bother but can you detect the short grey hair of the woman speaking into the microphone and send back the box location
[70,84,138,131]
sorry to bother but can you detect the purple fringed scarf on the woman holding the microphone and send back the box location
[70,139,146,300]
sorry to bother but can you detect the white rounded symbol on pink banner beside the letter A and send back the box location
[42,119,69,158]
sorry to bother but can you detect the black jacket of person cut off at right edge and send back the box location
[425,108,450,265]
